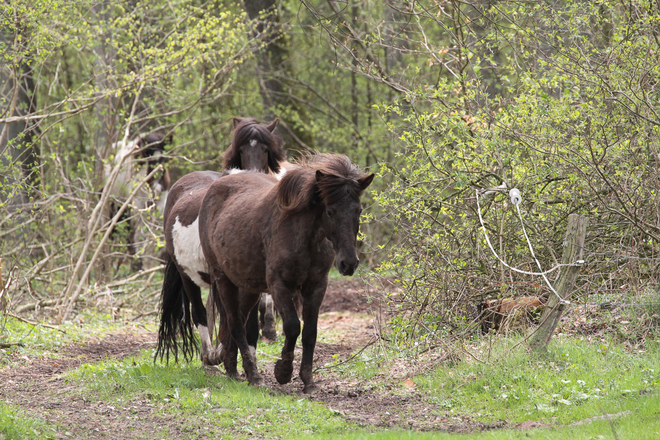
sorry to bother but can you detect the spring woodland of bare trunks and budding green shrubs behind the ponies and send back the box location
[0,0,660,342]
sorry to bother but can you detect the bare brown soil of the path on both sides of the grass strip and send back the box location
[0,279,506,439]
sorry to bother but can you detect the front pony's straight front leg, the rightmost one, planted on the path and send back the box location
[300,277,328,393]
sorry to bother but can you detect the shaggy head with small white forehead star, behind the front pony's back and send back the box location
[223,118,286,173]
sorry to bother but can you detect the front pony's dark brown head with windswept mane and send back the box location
[278,154,374,276]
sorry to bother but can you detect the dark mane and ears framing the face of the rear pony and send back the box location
[222,118,286,173]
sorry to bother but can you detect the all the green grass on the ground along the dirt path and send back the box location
[0,308,660,439]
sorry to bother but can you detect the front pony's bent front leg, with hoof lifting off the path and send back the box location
[272,284,300,384]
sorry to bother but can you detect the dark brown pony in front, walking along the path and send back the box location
[199,155,374,392]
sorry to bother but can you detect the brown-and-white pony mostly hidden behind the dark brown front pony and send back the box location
[156,118,286,365]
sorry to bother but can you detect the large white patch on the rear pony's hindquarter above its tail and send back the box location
[172,216,210,289]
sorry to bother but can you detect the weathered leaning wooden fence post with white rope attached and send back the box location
[529,214,587,353]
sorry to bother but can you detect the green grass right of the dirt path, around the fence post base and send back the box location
[301,337,660,440]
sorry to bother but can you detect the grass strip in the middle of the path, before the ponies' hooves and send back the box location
[68,351,350,438]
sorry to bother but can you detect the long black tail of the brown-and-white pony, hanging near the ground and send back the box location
[154,258,197,362]
